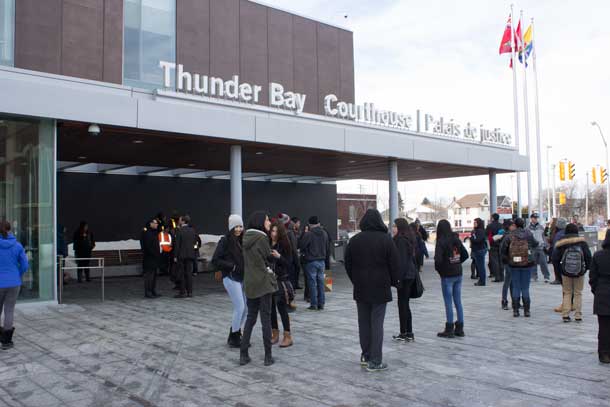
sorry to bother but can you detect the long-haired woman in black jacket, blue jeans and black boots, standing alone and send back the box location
[434,219,468,338]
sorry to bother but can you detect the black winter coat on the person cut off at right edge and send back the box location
[589,234,610,316]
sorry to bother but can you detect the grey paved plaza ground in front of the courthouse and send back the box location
[0,264,610,407]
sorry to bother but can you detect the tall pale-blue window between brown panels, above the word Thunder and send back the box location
[123,0,176,89]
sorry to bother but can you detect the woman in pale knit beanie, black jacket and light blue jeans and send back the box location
[212,215,248,348]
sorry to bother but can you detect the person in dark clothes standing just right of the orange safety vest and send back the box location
[174,215,197,298]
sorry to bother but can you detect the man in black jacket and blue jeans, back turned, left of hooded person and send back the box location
[299,216,330,311]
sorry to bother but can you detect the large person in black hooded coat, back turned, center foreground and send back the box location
[345,209,400,372]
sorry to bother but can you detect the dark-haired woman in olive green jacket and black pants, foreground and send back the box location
[239,211,277,366]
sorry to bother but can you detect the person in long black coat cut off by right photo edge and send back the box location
[589,232,610,363]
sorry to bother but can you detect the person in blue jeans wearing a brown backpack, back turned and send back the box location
[500,218,538,317]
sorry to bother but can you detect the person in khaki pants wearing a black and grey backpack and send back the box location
[553,223,591,322]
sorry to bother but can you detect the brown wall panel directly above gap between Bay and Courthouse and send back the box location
[292,16,323,114]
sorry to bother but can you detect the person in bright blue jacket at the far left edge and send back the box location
[0,220,28,349]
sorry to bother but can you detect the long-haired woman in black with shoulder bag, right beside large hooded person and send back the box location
[392,218,418,342]
